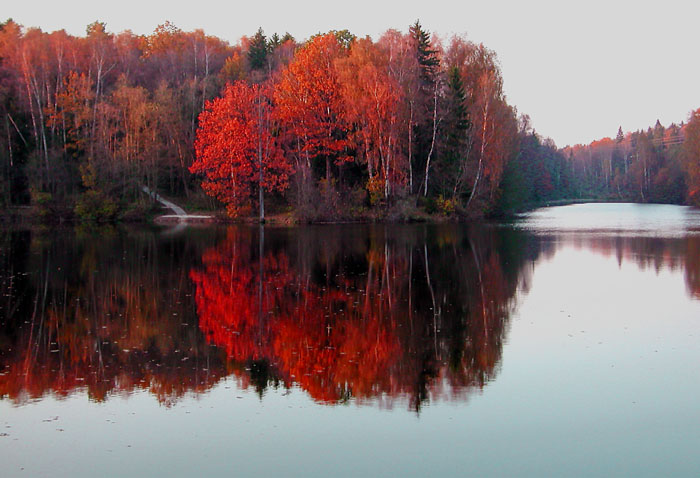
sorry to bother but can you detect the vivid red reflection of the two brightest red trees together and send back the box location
[191,230,399,402]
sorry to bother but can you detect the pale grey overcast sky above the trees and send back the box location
[0,0,700,146]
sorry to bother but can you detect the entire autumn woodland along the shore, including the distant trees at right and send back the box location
[0,20,700,221]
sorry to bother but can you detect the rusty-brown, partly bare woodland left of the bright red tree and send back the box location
[0,20,235,219]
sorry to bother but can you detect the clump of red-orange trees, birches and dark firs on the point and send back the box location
[191,23,518,219]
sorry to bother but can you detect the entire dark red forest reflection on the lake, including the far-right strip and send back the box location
[0,226,700,408]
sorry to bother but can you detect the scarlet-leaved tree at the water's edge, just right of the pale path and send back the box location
[190,81,291,221]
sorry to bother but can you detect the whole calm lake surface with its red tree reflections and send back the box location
[0,205,700,476]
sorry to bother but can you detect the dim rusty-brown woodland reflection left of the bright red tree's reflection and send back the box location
[0,230,224,403]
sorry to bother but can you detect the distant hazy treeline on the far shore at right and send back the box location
[502,110,700,209]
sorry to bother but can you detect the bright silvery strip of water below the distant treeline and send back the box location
[517,203,700,237]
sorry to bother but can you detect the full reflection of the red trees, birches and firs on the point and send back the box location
[191,226,540,408]
